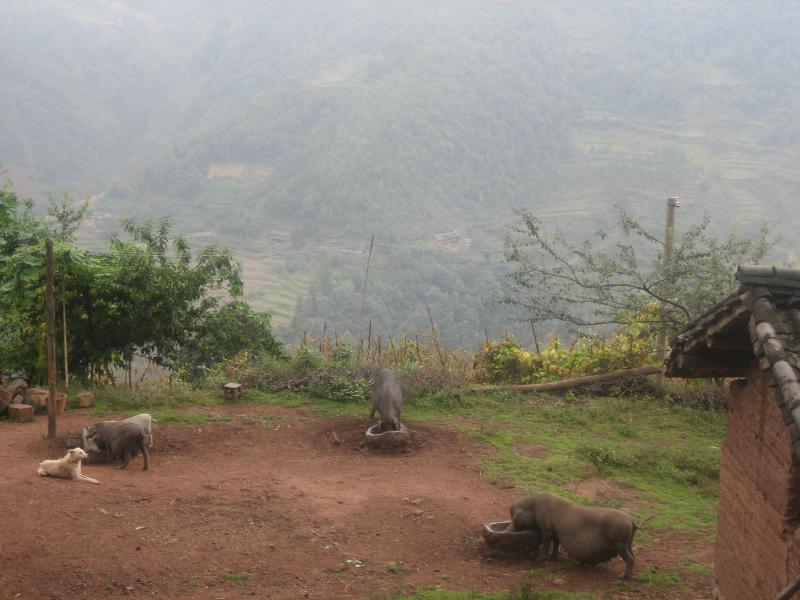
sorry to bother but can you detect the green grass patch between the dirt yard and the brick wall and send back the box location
[434,394,727,534]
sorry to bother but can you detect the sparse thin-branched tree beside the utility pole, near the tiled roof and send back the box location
[504,208,771,333]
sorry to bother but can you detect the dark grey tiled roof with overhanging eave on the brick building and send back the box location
[666,266,800,456]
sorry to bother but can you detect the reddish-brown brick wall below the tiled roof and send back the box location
[714,365,800,600]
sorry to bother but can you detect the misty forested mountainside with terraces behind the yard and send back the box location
[0,0,800,346]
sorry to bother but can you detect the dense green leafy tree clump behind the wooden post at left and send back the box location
[0,187,281,379]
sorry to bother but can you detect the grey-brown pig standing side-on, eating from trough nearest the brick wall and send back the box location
[510,494,638,579]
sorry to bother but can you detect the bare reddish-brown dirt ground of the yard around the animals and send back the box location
[0,405,710,599]
